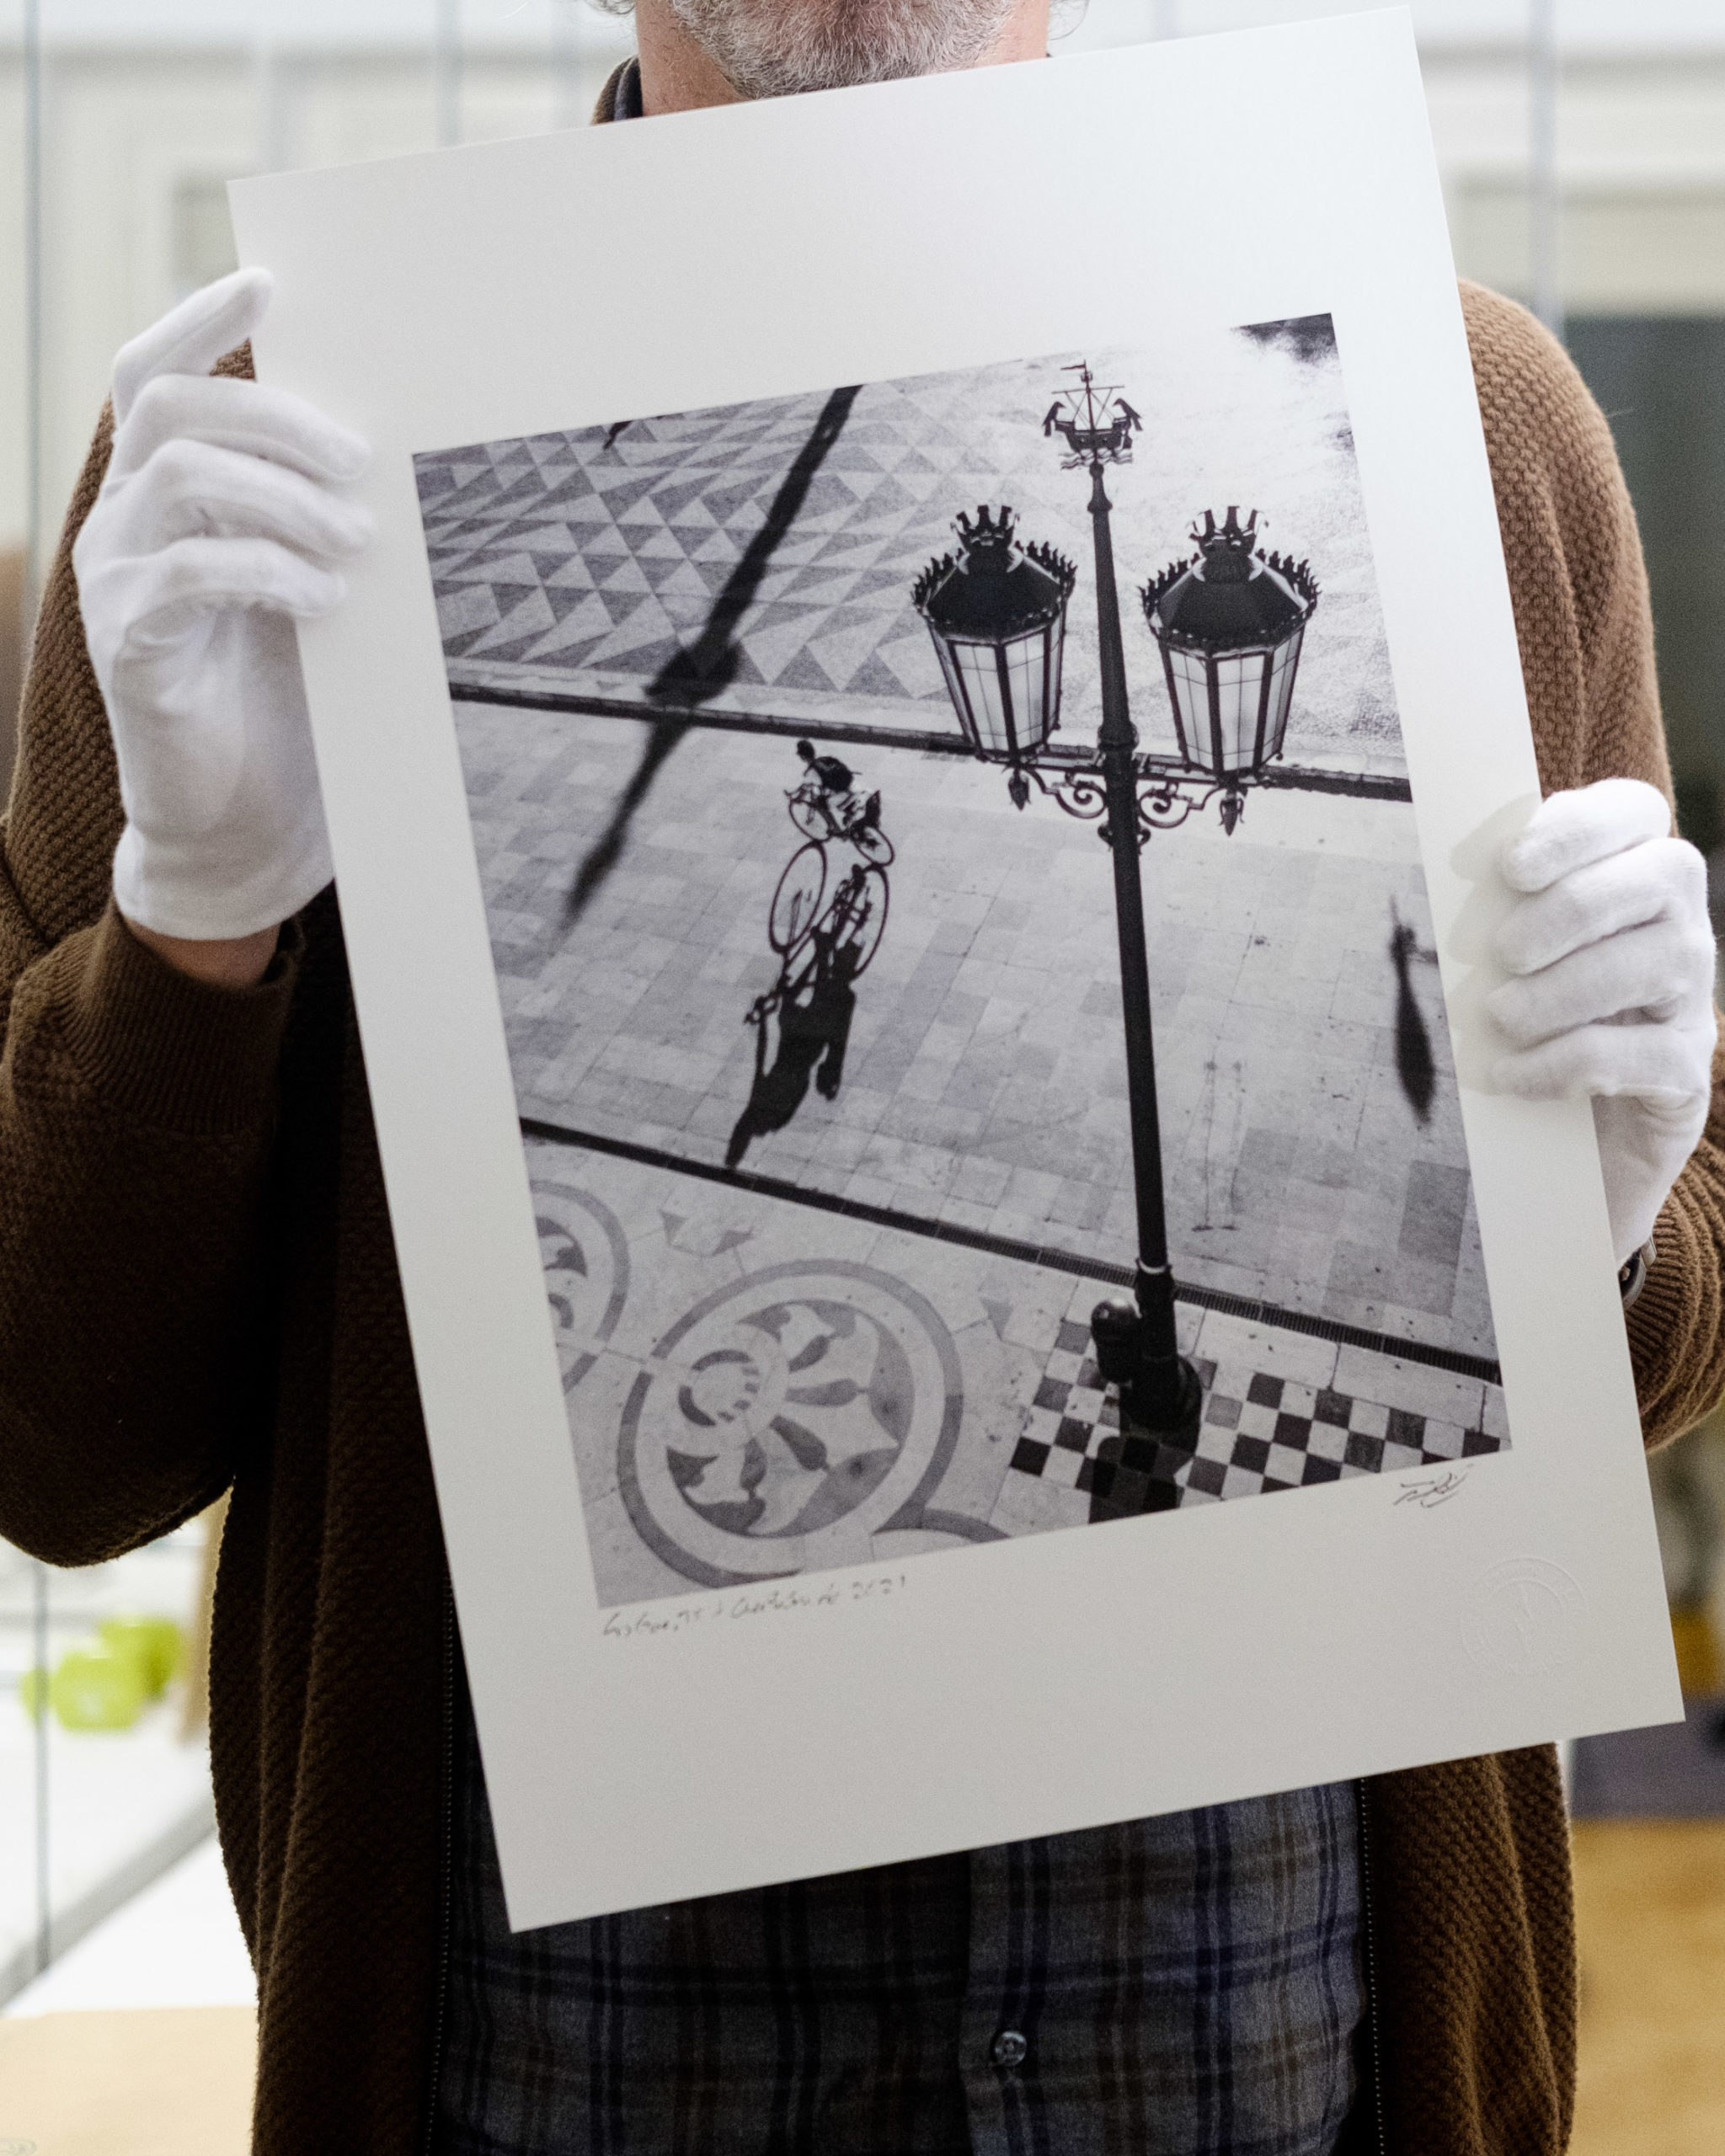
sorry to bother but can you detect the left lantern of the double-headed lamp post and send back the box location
[912,507,1078,808]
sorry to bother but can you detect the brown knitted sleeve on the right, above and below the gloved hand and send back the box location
[1462,285,1725,1444]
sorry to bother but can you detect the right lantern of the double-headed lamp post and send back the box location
[1143,509,1317,830]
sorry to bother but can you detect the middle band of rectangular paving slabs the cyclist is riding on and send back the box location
[457,705,1494,1358]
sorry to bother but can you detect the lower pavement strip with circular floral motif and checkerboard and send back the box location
[528,1143,1507,1606]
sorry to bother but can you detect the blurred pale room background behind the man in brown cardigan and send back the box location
[0,0,1725,2156]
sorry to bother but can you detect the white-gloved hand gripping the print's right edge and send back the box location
[1486,778,1717,1266]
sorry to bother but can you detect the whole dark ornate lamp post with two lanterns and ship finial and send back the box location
[912,365,1317,1443]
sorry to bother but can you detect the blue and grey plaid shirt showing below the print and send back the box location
[434,1681,1363,2156]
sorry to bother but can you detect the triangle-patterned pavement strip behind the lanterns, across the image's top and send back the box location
[416,330,1406,774]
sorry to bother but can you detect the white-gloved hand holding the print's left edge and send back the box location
[71,270,371,940]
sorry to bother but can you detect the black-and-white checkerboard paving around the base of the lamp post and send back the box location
[1007,1320,1505,1520]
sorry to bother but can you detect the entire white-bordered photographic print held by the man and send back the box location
[232,11,1678,1925]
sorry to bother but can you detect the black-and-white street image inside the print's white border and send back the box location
[414,315,1509,1606]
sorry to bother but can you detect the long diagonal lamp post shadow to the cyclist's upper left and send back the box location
[563,384,860,927]
